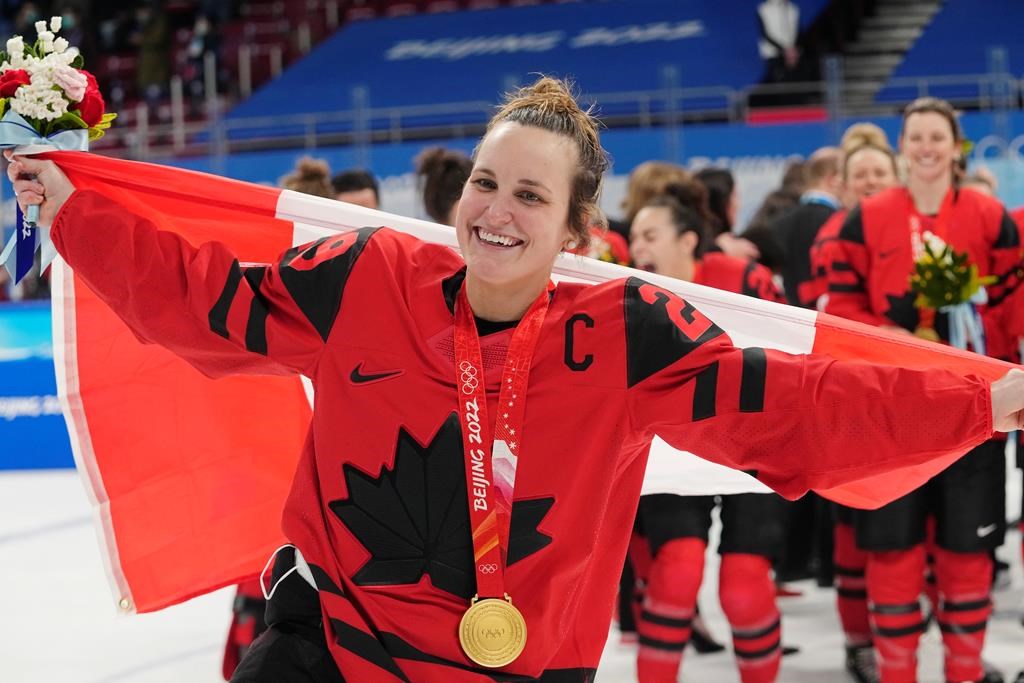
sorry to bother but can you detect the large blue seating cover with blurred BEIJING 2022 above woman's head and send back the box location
[222,0,827,135]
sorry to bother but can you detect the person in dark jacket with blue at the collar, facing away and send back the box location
[771,147,843,308]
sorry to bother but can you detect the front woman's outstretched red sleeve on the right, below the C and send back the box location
[625,279,992,499]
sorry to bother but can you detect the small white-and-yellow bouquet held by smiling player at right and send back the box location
[910,231,995,353]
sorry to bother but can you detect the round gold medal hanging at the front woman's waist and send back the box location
[459,595,526,669]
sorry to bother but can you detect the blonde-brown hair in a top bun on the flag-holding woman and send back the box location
[481,76,610,249]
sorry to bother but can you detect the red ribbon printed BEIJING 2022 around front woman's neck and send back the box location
[455,284,552,599]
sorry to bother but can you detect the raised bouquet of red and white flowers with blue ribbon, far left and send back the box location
[0,16,117,282]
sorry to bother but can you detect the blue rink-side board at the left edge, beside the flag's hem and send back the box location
[0,301,75,470]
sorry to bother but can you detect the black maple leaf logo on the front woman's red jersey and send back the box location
[329,413,555,598]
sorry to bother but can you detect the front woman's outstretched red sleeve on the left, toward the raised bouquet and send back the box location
[50,190,372,377]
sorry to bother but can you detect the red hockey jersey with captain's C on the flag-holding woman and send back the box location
[52,190,992,683]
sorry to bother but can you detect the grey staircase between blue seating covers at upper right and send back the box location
[844,0,943,115]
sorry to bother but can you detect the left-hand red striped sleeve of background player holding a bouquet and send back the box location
[825,206,892,327]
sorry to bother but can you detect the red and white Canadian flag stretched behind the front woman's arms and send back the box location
[41,153,1011,611]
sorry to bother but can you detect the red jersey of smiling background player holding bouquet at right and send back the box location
[825,187,1024,358]
